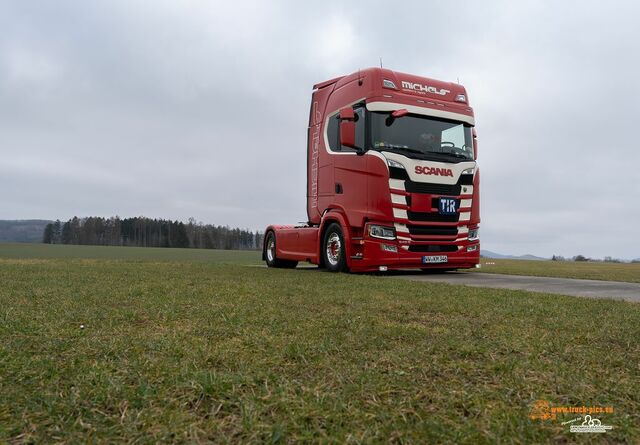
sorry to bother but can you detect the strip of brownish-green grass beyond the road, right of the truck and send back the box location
[473,258,640,283]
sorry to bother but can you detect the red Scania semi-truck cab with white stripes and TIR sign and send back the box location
[262,68,480,272]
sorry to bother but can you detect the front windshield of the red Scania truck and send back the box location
[371,111,473,162]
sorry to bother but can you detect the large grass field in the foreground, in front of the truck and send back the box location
[0,246,640,444]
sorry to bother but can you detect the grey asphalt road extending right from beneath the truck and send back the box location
[394,272,640,302]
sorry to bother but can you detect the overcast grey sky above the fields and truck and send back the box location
[0,0,640,258]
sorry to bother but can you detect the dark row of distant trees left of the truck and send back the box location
[42,216,263,250]
